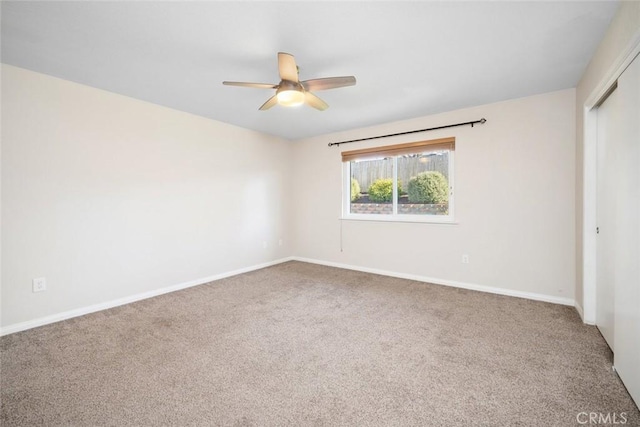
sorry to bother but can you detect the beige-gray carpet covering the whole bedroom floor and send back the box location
[1,262,640,426]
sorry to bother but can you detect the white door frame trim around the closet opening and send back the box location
[577,30,640,325]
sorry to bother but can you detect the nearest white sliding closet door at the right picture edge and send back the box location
[598,57,640,406]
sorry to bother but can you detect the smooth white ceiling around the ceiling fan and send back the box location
[1,1,618,139]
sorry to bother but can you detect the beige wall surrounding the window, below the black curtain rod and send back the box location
[293,89,575,303]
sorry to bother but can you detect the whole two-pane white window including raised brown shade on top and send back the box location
[342,137,455,222]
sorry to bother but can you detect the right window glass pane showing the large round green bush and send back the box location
[398,150,449,215]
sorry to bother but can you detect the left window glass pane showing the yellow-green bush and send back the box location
[349,157,393,215]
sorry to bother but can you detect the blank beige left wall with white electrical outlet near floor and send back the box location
[2,65,291,327]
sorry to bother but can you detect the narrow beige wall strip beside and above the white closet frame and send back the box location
[576,1,640,314]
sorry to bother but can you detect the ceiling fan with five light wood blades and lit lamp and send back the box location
[222,52,356,111]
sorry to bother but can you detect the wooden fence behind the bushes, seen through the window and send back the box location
[351,152,449,193]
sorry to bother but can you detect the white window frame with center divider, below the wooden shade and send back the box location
[342,145,455,224]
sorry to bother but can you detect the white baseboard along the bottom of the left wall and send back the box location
[0,257,293,336]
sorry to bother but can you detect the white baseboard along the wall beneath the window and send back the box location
[291,256,576,307]
